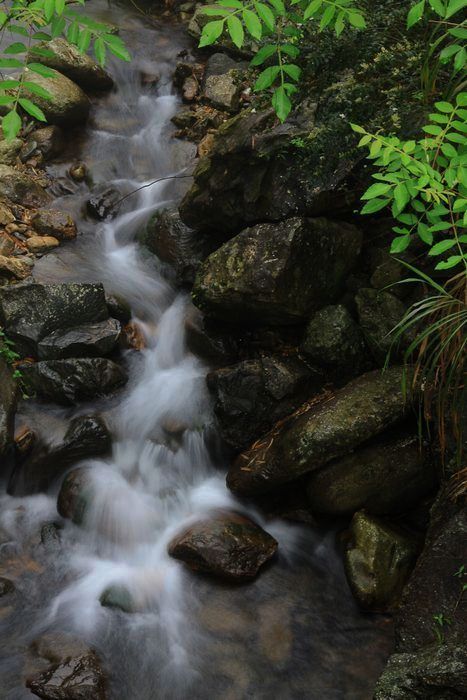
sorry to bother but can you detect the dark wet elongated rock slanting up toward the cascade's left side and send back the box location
[8,414,112,496]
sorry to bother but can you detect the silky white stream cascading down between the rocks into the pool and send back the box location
[0,0,391,700]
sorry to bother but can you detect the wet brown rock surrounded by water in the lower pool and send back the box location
[169,513,277,581]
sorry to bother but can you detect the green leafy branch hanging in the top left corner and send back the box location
[0,0,130,139]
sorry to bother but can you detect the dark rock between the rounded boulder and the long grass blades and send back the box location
[355,288,412,364]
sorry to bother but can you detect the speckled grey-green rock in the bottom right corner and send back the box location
[374,644,467,700]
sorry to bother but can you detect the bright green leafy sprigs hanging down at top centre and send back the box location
[199,0,366,121]
